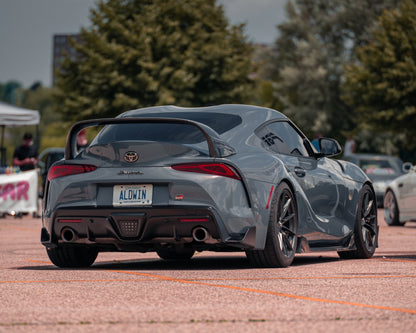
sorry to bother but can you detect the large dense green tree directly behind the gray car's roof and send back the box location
[57,0,252,121]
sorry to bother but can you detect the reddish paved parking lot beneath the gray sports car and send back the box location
[0,210,416,332]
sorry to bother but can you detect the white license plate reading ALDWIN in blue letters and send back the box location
[113,185,153,206]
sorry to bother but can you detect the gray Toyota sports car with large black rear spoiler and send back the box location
[41,105,378,267]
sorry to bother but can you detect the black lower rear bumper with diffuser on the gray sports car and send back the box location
[41,206,256,252]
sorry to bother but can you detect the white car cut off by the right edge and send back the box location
[384,163,416,225]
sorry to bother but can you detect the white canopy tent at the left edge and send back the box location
[0,102,40,165]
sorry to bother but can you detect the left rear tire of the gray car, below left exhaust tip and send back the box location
[46,245,98,268]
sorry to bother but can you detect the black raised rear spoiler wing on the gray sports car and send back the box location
[65,117,235,160]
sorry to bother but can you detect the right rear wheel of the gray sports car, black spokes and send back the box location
[246,182,298,267]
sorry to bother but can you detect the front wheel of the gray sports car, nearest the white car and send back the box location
[338,184,378,259]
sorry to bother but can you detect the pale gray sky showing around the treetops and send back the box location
[0,0,287,88]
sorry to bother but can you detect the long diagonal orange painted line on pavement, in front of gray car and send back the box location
[108,270,416,314]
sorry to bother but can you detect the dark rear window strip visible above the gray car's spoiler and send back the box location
[122,112,242,134]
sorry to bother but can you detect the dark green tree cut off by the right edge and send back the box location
[343,0,416,149]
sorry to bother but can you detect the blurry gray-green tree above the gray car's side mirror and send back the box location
[273,0,398,139]
